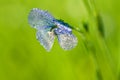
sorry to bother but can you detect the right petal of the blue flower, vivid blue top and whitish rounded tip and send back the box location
[54,20,78,50]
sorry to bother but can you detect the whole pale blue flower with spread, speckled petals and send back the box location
[28,8,78,51]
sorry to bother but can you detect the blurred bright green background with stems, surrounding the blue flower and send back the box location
[0,0,120,80]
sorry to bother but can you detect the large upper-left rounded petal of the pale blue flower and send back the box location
[28,8,54,29]
